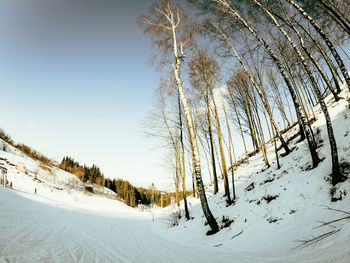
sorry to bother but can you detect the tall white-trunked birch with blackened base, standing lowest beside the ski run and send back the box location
[140,0,219,233]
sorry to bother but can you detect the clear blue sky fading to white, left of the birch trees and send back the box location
[0,0,176,190]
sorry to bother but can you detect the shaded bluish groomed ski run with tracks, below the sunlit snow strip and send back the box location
[0,188,238,262]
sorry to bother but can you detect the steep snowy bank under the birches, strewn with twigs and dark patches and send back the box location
[155,87,350,262]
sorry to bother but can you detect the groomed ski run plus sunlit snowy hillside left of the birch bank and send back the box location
[0,148,235,263]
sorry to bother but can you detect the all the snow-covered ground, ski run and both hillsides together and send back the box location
[0,88,350,262]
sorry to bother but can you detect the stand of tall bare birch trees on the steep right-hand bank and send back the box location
[139,0,350,232]
